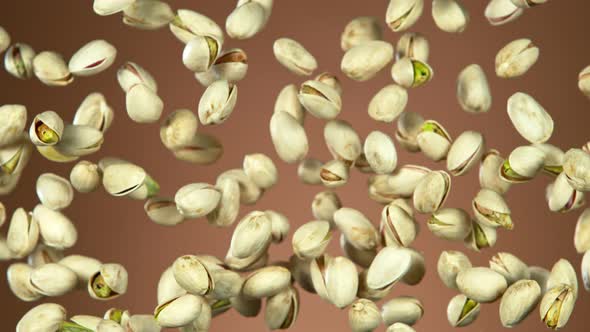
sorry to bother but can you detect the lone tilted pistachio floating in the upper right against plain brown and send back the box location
[496,38,539,78]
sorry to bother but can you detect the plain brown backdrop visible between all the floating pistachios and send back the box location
[0,0,590,331]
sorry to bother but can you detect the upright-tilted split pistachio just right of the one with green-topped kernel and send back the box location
[447,130,486,176]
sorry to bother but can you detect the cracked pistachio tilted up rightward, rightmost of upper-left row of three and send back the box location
[68,39,117,76]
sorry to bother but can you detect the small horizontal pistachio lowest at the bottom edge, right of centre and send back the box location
[381,296,424,326]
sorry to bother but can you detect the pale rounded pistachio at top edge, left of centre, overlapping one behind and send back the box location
[225,1,267,40]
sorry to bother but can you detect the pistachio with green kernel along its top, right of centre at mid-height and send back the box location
[416,120,453,161]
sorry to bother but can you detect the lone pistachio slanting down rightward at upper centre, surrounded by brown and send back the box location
[272,38,318,76]
